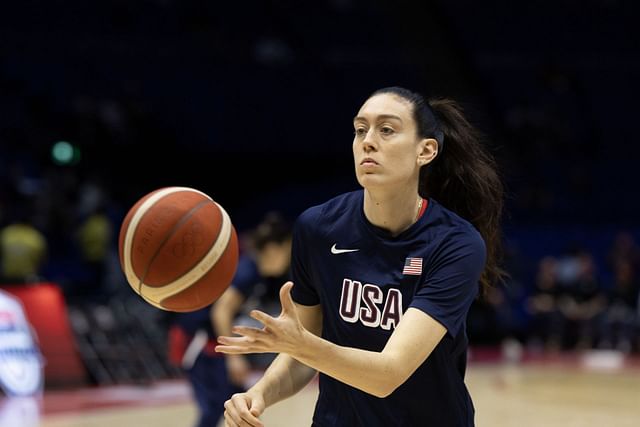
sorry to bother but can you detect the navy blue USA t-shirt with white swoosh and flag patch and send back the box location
[292,191,486,427]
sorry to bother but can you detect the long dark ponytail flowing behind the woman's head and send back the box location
[419,99,506,294]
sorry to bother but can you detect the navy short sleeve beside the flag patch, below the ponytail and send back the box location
[410,230,486,337]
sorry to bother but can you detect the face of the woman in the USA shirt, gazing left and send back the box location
[353,94,426,192]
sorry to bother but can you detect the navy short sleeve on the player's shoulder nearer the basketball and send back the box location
[291,211,320,305]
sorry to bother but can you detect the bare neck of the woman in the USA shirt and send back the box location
[364,189,422,236]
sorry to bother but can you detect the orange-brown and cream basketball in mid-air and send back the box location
[118,187,238,312]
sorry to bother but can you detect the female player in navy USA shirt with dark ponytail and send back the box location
[217,87,503,427]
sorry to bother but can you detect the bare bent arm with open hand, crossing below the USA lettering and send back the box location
[218,282,446,397]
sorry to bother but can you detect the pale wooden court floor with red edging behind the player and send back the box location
[7,363,640,427]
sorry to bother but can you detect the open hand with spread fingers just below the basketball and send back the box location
[216,282,308,356]
